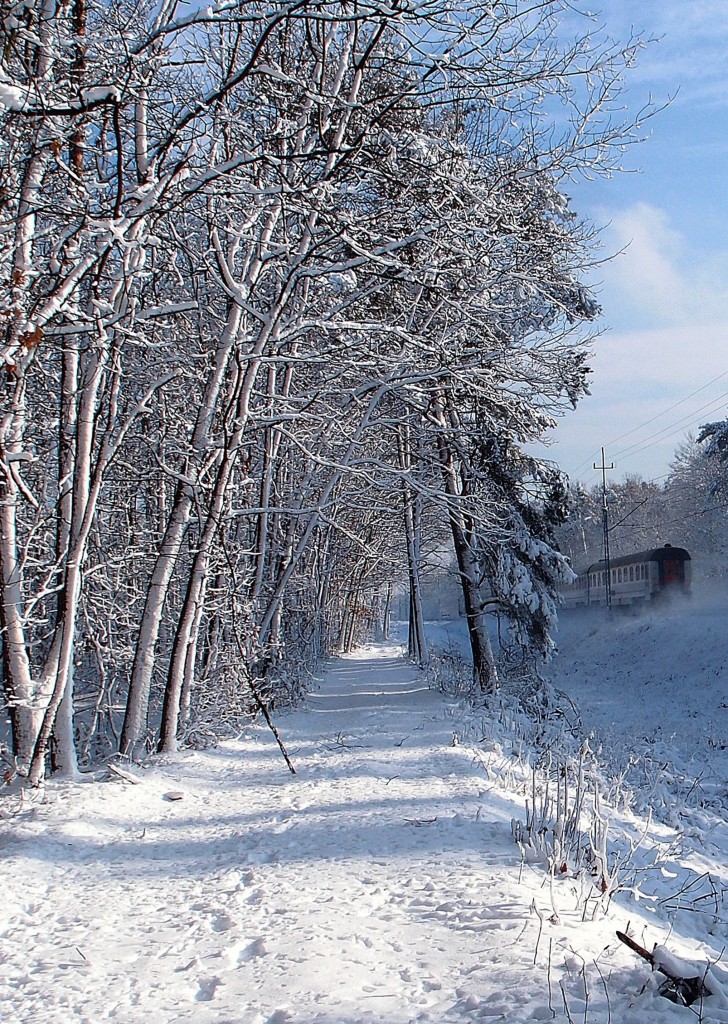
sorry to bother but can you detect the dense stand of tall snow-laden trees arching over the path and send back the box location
[0,0,651,781]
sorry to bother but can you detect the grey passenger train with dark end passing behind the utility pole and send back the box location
[560,544,692,608]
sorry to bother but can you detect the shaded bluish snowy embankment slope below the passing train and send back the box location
[428,589,728,810]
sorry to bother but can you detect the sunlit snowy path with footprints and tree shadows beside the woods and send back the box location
[0,645,551,1024]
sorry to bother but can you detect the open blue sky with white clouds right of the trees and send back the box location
[548,0,728,484]
